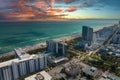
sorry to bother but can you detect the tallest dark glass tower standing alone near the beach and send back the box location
[82,26,93,45]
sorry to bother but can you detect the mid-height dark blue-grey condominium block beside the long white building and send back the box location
[46,40,67,56]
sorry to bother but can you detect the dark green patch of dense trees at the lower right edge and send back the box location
[87,54,120,76]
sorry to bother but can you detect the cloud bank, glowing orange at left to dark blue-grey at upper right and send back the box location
[0,0,120,19]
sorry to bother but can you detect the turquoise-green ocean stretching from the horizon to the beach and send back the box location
[0,20,118,54]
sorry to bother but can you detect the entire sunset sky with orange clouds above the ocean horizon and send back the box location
[0,0,120,20]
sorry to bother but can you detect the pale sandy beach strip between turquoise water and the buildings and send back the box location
[0,25,113,58]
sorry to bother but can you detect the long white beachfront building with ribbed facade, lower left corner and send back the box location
[0,49,47,80]
